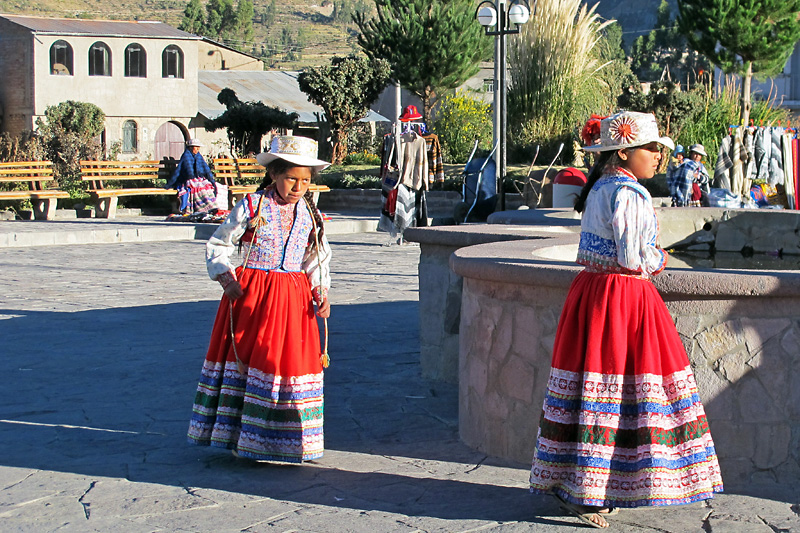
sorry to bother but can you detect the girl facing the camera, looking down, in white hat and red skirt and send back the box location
[189,136,331,463]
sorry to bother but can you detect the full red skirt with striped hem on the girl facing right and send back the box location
[530,272,722,507]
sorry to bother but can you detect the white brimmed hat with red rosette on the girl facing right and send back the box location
[583,111,675,152]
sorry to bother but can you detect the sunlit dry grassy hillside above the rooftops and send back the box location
[0,0,358,70]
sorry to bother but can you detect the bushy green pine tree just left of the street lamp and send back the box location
[353,0,492,119]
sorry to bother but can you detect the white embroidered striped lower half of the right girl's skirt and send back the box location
[531,367,722,507]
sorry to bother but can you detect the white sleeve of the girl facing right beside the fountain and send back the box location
[612,187,667,275]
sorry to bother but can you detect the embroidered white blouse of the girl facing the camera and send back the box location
[206,189,331,297]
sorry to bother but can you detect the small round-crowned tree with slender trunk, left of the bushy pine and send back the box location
[297,55,391,164]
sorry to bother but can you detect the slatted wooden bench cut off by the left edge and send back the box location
[0,161,69,220]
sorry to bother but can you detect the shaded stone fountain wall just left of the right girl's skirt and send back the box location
[458,279,567,463]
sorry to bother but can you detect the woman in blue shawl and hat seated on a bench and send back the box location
[166,139,217,215]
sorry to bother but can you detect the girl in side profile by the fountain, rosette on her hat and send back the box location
[530,112,722,528]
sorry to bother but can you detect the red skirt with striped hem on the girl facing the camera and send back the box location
[188,267,323,462]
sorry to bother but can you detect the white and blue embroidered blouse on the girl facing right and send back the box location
[577,169,667,278]
